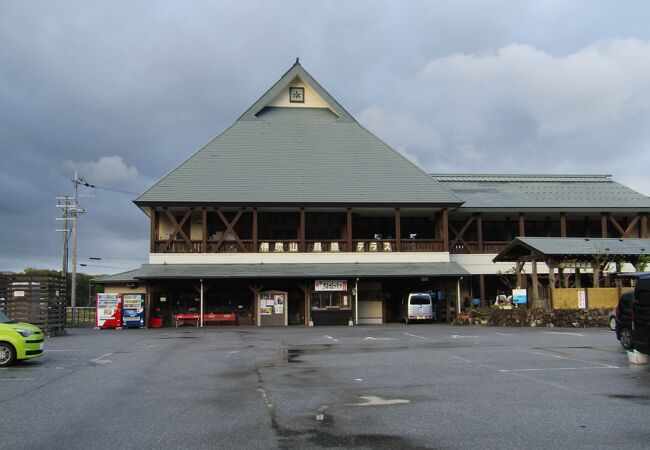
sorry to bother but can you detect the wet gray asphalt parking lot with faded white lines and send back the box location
[0,324,650,449]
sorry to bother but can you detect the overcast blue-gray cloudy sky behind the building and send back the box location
[0,0,650,273]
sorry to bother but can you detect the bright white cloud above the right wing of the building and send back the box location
[419,39,650,138]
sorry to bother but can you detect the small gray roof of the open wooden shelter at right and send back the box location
[494,237,650,262]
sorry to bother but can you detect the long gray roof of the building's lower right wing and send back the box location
[431,174,650,212]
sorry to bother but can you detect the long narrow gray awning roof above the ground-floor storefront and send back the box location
[129,262,470,280]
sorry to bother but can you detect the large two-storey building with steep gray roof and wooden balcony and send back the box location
[93,61,650,325]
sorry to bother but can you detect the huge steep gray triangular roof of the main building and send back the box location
[135,60,461,206]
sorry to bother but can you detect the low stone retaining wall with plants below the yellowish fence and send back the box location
[487,308,611,328]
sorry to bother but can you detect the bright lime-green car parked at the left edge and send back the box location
[0,311,45,367]
